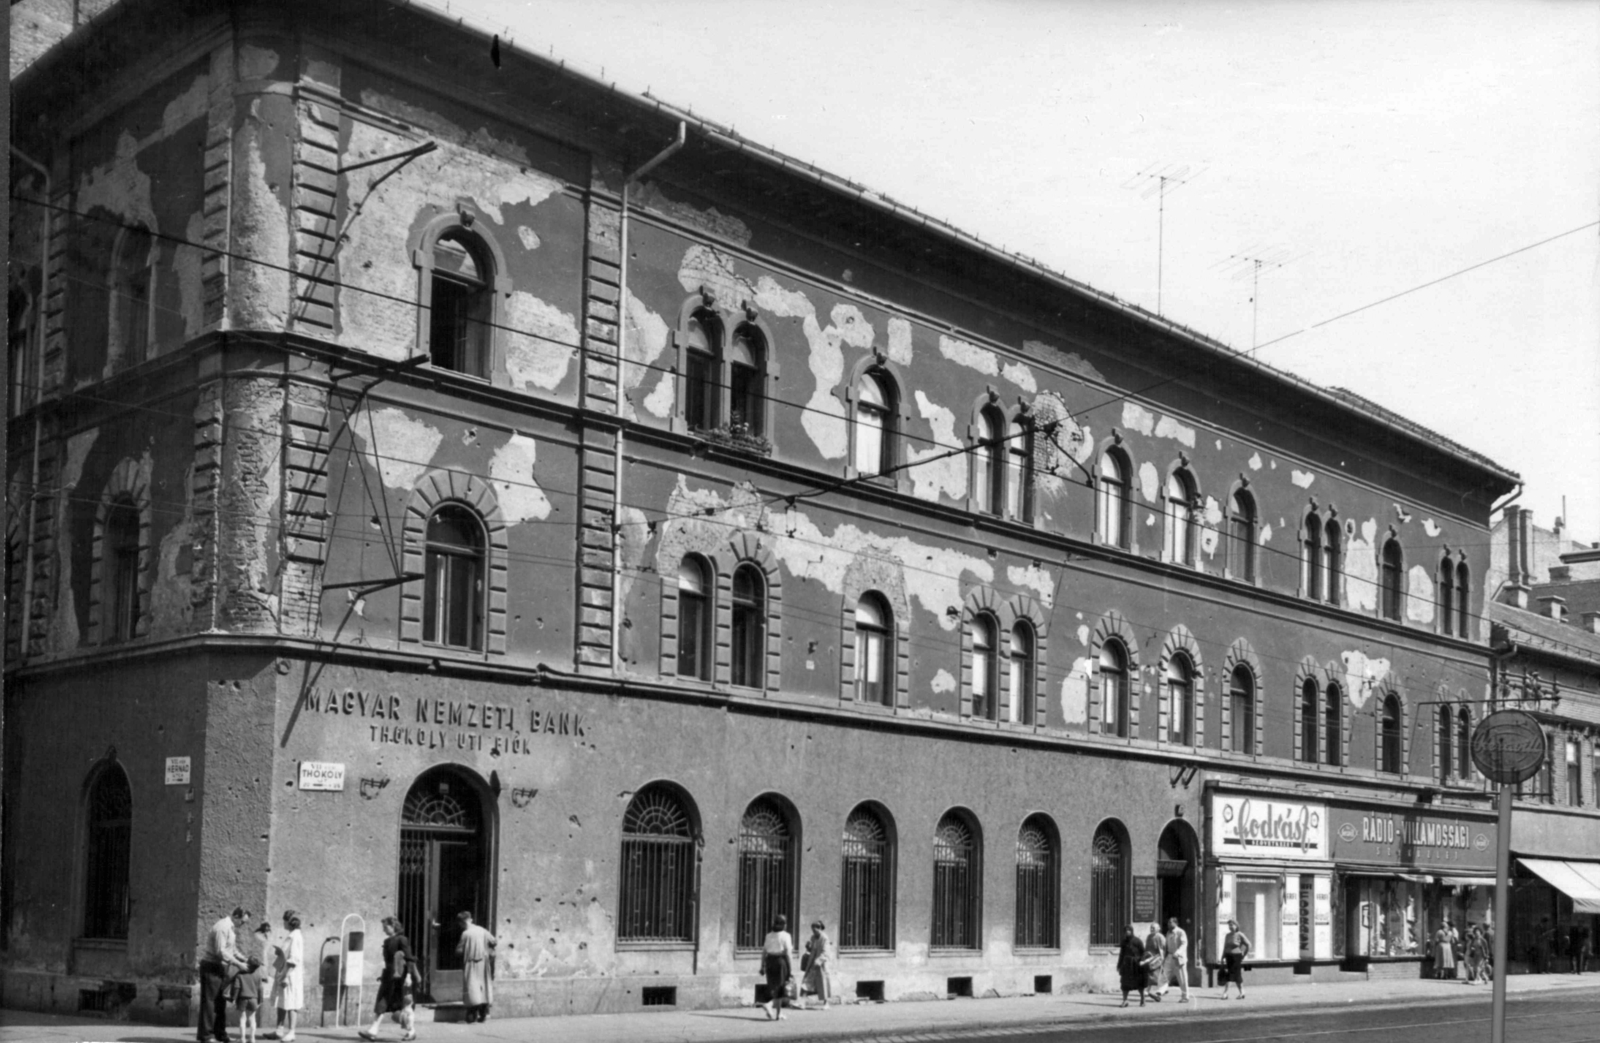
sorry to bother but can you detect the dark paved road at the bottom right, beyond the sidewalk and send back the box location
[859,989,1600,1043]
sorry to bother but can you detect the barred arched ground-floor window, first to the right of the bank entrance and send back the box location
[616,784,696,942]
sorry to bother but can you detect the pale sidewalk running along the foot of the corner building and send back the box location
[0,974,1600,1043]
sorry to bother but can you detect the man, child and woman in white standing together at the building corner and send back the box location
[195,905,306,1043]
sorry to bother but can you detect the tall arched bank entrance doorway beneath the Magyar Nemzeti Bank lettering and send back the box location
[398,768,494,1003]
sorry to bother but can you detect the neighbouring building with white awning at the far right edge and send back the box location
[1488,515,1600,969]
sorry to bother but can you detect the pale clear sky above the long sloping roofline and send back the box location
[427,0,1600,542]
